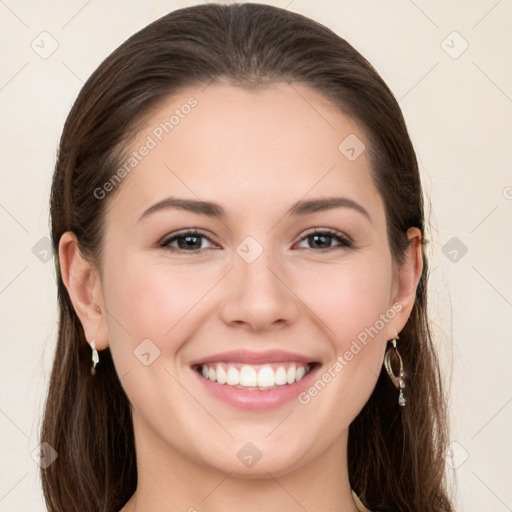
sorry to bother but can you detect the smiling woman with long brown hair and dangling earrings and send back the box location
[41,3,453,512]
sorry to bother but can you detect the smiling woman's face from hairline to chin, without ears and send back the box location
[90,83,404,477]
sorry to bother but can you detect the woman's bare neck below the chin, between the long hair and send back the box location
[121,418,358,512]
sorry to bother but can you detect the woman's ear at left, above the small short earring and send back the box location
[59,231,108,350]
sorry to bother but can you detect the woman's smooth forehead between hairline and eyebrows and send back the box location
[108,82,382,226]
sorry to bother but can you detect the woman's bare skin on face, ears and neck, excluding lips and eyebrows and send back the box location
[60,83,422,512]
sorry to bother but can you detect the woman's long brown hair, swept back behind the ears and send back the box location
[41,3,453,512]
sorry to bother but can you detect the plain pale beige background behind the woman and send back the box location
[0,0,512,512]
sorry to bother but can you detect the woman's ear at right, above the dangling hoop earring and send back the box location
[387,227,423,340]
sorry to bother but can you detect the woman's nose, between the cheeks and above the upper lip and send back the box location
[220,239,300,331]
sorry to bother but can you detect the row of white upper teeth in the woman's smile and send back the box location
[197,363,311,389]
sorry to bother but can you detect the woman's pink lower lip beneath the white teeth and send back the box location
[192,365,320,411]
